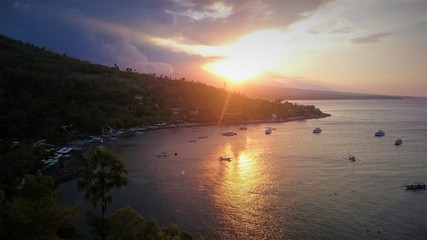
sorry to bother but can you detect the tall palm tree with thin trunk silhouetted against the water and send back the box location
[77,147,129,239]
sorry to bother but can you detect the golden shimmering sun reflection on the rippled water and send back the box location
[207,135,280,238]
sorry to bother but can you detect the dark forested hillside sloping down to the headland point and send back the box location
[0,35,328,142]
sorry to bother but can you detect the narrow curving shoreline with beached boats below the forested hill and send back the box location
[51,113,331,188]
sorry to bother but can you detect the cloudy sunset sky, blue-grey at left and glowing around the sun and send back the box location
[0,0,427,97]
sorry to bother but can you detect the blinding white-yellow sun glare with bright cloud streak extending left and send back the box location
[151,29,295,83]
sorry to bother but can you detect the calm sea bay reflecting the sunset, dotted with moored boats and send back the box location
[57,98,427,239]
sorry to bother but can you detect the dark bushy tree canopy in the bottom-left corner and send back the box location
[0,172,77,239]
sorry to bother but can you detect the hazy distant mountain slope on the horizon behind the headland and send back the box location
[236,84,401,100]
